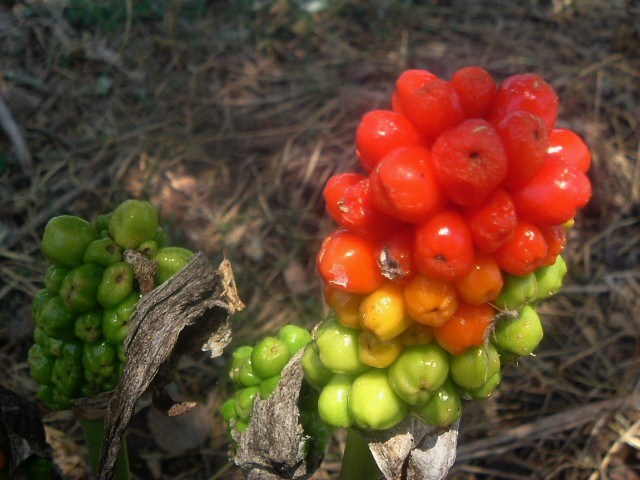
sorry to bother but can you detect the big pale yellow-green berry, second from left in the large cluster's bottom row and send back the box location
[349,368,407,430]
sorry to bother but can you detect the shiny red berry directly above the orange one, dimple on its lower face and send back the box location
[413,210,474,282]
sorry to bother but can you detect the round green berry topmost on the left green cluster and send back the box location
[109,200,158,249]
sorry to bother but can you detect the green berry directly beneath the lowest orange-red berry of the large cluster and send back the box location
[449,344,500,389]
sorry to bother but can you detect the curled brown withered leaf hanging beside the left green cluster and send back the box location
[98,253,244,480]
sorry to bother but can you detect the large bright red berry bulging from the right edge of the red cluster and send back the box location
[511,157,591,226]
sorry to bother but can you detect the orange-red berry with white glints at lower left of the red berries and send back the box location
[316,230,384,294]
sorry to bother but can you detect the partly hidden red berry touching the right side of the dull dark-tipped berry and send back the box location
[496,110,549,188]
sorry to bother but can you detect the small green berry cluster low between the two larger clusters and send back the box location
[220,325,328,452]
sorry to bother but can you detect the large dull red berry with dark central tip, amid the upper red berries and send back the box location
[431,119,507,206]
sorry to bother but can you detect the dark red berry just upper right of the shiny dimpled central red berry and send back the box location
[464,188,518,253]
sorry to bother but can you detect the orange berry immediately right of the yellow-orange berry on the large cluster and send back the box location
[404,274,458,327]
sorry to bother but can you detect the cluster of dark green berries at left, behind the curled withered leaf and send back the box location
[28,200,193,409]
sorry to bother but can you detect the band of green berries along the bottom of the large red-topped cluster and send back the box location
[302,256,567,430]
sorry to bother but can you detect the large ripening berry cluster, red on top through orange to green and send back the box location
[305,67,591,429]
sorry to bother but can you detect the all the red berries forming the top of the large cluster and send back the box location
[317,67,591,300]
